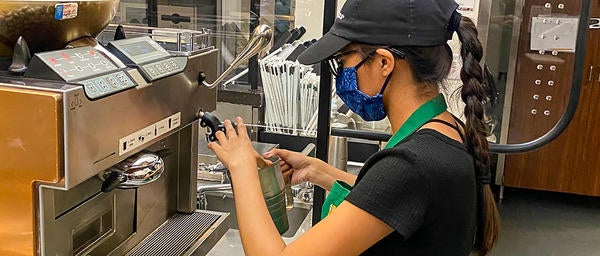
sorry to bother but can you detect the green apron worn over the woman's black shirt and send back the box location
[321,93,447,219]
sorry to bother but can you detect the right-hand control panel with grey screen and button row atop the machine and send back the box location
[108,37,187,82]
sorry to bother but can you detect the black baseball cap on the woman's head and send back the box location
[298,0,458,65]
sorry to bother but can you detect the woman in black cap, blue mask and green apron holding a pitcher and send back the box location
[209,0,499,255]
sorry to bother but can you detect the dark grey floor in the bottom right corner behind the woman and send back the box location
[492,189,600,256]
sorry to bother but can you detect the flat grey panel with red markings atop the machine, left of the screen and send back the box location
[36,46,119,82]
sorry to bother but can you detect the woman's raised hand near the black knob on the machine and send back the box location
[208,117,272,171]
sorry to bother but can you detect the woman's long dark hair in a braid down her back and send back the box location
[358,17,500,256]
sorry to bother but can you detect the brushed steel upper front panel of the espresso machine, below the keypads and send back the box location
[59,50,217,189]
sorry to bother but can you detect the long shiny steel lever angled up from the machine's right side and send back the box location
[198,25,273,89]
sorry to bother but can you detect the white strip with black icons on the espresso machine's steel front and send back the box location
[119,112,181,156]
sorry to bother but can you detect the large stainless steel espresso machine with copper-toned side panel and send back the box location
[0,0,272,255]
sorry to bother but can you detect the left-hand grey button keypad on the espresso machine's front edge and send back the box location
[79,71,136,99]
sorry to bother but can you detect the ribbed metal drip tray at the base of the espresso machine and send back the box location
[127,211,229,256]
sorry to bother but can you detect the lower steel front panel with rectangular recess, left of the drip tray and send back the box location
[41,179,136,255]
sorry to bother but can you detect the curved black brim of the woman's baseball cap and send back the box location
[298,32,350,65]
